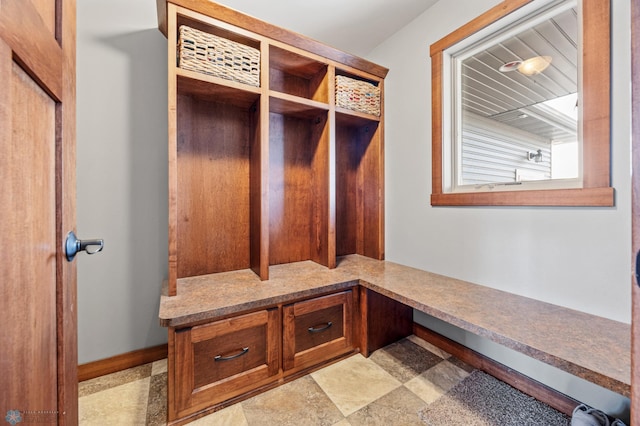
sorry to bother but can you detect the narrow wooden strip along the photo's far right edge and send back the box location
[631,0,640,425]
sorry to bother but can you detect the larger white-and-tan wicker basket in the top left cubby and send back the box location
[178,25,260,86]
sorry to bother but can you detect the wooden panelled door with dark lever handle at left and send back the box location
[0,0,78,424]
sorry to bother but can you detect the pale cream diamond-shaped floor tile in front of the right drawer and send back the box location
[311,354,401,416]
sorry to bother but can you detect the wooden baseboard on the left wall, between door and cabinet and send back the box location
[78,344,167,382]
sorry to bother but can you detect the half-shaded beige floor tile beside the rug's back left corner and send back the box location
[404,361,469,404]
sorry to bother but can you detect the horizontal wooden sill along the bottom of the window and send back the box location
[431,187,614,207]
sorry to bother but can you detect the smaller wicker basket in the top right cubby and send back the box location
[336,75,380,116]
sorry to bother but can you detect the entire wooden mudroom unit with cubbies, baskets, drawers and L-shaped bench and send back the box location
[157,0,630,424]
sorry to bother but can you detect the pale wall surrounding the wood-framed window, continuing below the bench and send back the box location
[368,0,631,417]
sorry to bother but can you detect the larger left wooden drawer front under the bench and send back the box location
[175,308,280,417]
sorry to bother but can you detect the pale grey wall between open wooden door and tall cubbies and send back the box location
[76,0,168,364]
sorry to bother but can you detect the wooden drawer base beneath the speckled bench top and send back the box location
[168,284,413,424]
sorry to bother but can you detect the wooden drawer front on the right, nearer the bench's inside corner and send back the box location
[283,290,353,370]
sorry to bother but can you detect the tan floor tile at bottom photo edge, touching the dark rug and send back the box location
[348,386,427,426]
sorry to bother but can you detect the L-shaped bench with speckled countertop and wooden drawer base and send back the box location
[160,255,631,419]
